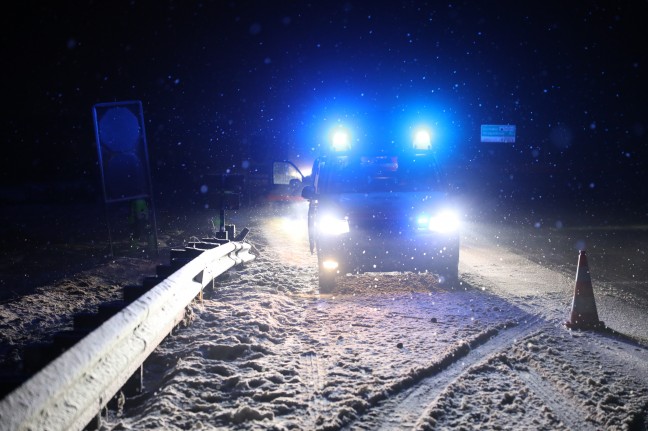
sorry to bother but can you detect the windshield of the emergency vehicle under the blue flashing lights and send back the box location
[318,156,441,194]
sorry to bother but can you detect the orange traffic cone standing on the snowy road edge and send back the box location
[565,250,604,329]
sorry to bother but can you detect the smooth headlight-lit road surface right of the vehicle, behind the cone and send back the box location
[461,219,648,345]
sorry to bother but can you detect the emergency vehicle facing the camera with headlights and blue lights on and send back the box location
[302,126,459,292]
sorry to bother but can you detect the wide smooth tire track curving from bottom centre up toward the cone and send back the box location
[344,317,542,430]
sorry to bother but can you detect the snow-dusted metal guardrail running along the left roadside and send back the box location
[0,241,255,430]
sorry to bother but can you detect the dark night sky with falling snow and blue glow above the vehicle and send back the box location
[0,1,648,209]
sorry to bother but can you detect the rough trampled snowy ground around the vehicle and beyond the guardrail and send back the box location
[0,205,648,430]
